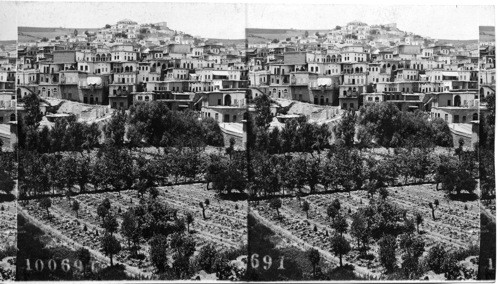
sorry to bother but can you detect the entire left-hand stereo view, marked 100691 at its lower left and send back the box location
[15,2,248,281]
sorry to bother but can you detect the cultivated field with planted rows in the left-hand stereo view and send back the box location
[21,184,247,277]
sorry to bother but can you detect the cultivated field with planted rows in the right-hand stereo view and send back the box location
[251,185,480,277]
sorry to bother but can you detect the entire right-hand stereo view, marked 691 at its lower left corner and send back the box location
[246,4,495,281]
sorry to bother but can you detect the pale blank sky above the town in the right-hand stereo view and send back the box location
[248,4,495,39]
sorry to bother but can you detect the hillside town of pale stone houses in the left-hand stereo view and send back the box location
[15,20,248,131]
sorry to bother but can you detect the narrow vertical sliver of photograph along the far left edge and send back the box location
[0,2,17,281]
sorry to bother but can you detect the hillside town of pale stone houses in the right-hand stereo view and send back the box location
[248,22,488,146]
